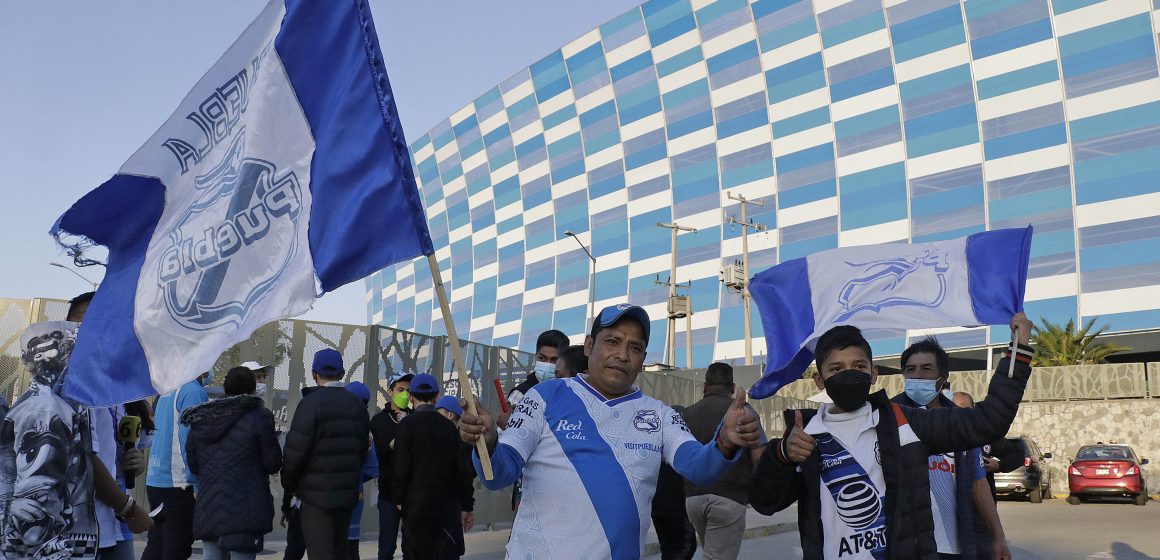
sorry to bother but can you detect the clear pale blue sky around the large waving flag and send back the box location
[0,0,639,323]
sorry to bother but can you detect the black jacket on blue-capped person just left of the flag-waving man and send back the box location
[391,405,476,518]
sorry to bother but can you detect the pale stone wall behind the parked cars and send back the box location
[1009,399,1160,494]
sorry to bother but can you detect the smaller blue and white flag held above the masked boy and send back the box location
[749,226,1031,399]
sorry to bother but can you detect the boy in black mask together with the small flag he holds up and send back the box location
[749,227,1032,560]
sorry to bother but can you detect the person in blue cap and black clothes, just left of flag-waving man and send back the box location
[391,373,474,560]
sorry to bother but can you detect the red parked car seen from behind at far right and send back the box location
[1067,444,1148,506]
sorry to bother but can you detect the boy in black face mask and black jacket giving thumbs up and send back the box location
[749,313,1032,560]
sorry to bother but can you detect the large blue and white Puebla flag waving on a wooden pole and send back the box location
[52,0,434,405]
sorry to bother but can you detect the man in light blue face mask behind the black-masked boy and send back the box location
[892,339,1010,560]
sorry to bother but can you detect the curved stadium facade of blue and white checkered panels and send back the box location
[367,0,1160,366]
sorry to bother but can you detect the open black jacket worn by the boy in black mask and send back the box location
[749,358,1031,560]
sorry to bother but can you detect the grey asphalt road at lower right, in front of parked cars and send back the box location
[728,499,1160,560]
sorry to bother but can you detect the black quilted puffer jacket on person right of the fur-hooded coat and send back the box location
[282,386,370,509]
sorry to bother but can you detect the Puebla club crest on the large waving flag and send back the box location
[157,128,303,330]
